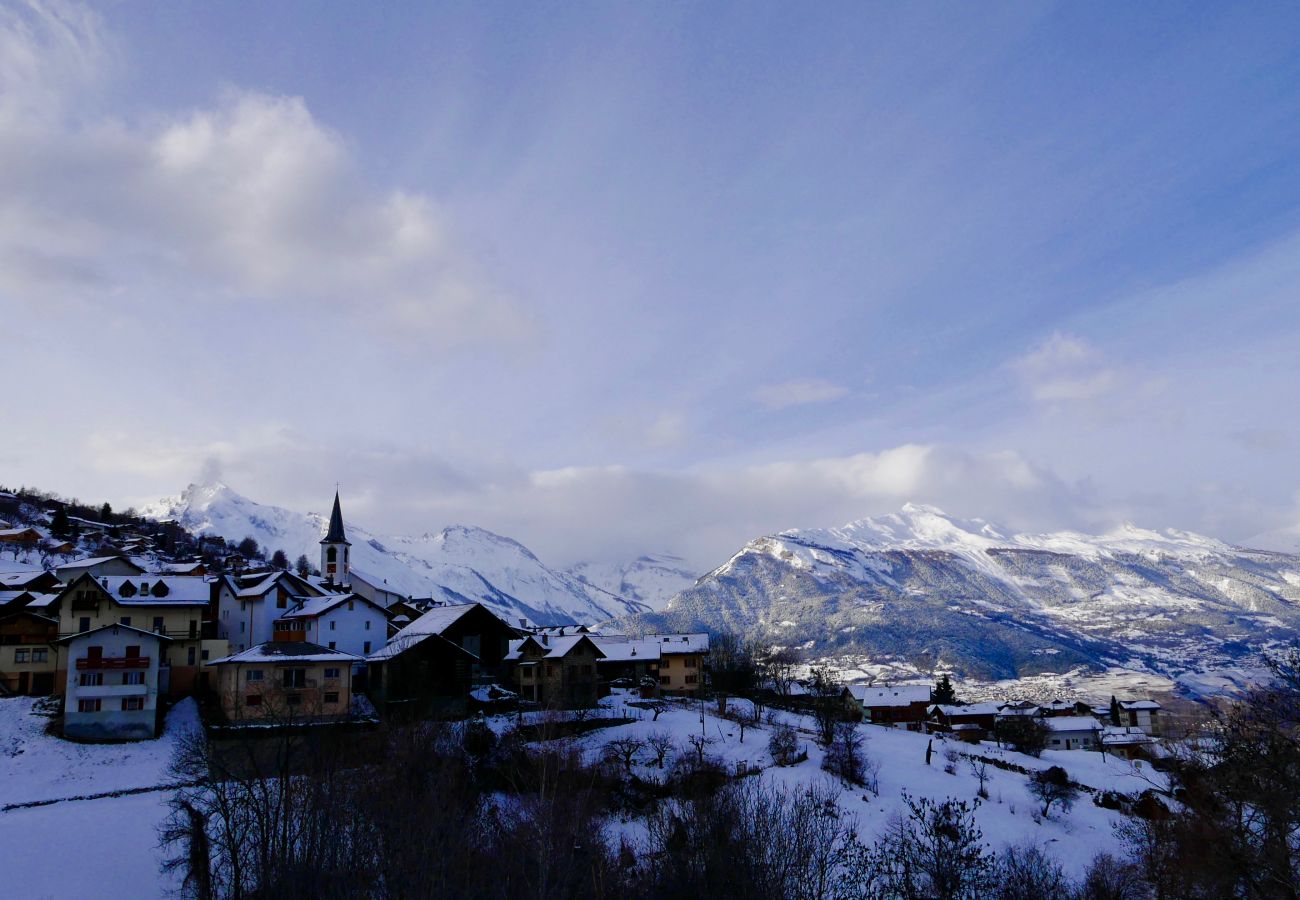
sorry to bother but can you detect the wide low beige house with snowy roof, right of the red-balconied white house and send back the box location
[213,641,361,724]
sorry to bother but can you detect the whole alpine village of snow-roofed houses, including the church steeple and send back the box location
[0,494,1161,758]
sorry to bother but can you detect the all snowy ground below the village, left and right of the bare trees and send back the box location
[0,693,1162,899]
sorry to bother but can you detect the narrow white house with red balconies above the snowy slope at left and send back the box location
[59,624,172,740]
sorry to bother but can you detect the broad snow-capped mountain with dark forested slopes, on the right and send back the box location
[634,505,1300,678]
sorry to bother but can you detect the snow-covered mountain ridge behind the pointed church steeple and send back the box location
[143,483,646,624]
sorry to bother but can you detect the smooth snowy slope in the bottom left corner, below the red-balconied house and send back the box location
[0,697,198,900]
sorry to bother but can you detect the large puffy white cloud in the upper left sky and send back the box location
[0,5,530,345]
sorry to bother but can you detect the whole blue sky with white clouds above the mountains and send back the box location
[0,0,1300,568]
